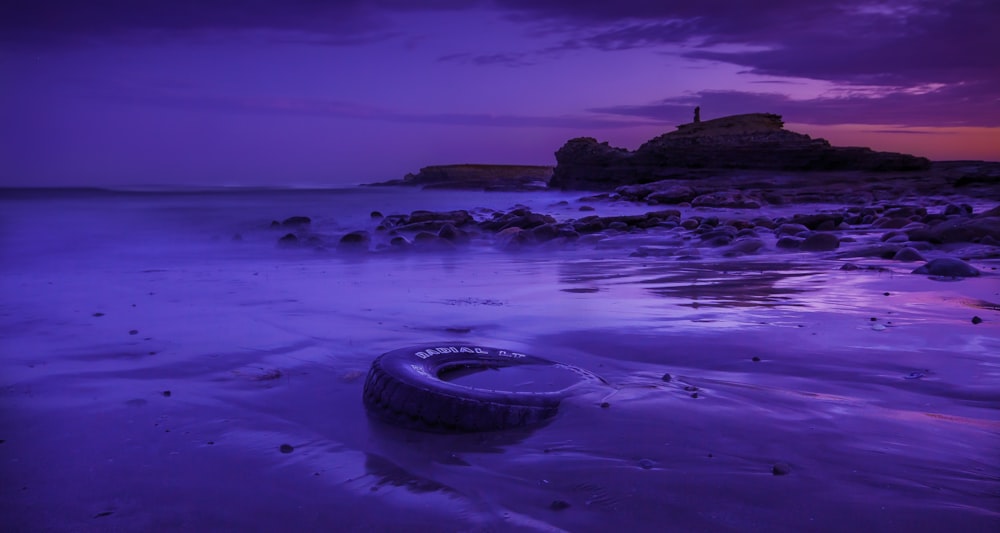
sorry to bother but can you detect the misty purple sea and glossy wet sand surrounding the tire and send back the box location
[0,188,1000,531]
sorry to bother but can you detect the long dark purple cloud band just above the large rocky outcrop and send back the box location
[591,84,1000,127]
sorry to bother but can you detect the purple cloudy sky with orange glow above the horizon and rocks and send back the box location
[0,0,1000,185]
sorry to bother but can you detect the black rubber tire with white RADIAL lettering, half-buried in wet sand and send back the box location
[363,344,604,432]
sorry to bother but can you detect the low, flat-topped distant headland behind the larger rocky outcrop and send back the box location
[375,164,552,191]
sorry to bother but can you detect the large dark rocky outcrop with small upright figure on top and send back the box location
[549,113,930,190]
